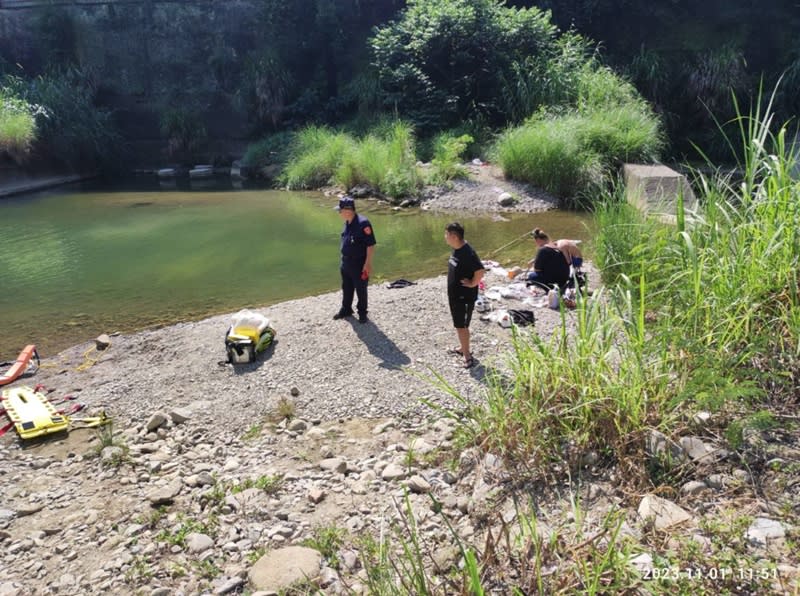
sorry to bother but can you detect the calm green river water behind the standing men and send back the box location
[0,180,589,358]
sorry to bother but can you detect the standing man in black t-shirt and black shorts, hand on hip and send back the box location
[444,222,484,368]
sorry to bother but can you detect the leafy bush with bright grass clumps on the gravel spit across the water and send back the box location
[270,1,663,204]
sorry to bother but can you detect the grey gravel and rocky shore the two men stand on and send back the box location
[0,170,800,596]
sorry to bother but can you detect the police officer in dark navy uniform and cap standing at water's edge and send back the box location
[333,196,375,323]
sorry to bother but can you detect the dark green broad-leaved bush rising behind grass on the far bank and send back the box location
[371,0,557,130]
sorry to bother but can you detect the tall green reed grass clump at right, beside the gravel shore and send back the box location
[440,87,800,485]
